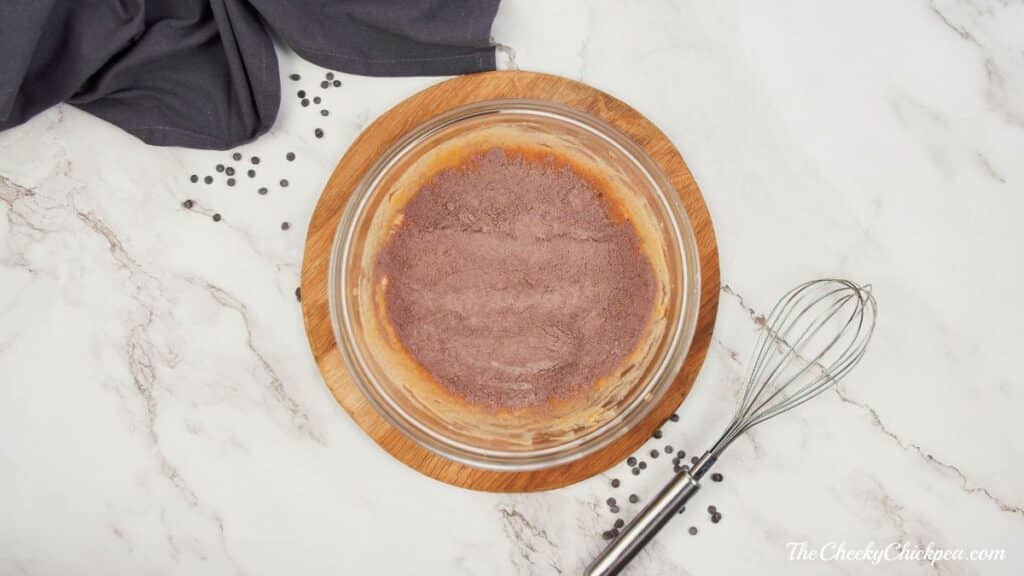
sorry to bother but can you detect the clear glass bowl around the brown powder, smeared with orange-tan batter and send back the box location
[328,99,700,471]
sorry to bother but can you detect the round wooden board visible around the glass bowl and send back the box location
[301,72,719,492]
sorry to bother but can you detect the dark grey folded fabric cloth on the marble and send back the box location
[0,0,499,149]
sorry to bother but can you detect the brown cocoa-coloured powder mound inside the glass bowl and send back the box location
[378,149,654,409]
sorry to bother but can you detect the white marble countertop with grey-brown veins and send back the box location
[0,0,1024,575]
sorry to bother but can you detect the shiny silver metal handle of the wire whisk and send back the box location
[584,469,700,576]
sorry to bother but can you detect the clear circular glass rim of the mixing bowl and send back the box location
[328,98,701,471]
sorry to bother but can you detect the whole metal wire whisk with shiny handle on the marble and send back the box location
[586,279,877,576]
